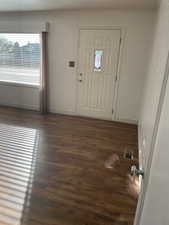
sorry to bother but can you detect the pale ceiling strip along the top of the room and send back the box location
[0,0,159,11]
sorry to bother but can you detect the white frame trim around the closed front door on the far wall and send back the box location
[76,26,126,121]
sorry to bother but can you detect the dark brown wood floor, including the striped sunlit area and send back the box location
[0,108,138,225]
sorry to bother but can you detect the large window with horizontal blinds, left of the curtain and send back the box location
[0,33,41,85]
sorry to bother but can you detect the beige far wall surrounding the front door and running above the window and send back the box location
[0,10,156,122]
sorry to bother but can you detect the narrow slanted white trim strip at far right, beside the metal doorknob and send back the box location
[134,51,169,225]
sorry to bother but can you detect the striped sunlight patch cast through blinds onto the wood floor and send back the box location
[0,124,39,225]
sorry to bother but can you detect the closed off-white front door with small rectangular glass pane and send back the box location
[77,29,121,120]
